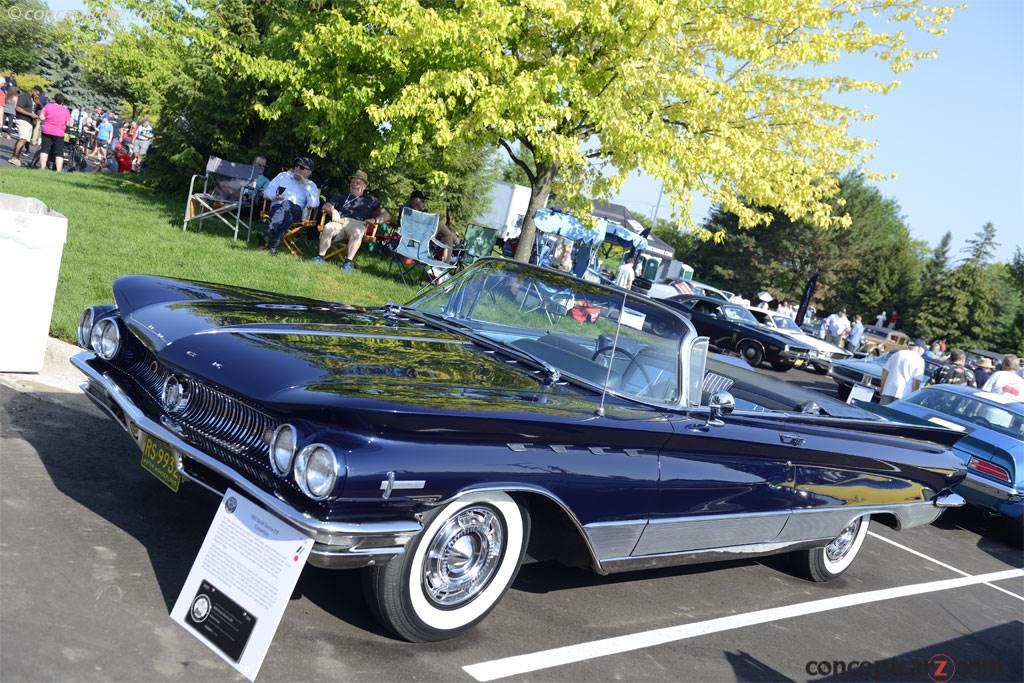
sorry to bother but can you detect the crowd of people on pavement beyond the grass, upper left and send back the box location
[0,75,154,173]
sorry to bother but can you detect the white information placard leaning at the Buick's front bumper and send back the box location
[171,488,313,681]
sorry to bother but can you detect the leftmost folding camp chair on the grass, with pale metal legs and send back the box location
[181,157,259,242]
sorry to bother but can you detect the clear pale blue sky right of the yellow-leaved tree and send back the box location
[614,0,1024,261]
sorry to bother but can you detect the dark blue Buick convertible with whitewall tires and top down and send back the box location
[72,259,965,641]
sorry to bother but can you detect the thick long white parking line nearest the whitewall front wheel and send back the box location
[462,569,1024,681]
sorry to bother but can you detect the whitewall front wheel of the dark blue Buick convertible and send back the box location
[365,492,529,642]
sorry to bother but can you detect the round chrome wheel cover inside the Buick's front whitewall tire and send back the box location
[423,506,505,608]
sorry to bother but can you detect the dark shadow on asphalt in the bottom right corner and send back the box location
[808,621,1024,682]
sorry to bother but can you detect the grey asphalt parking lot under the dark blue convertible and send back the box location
[0,371,1024,681]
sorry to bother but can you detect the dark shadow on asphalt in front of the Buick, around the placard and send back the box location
[0,385,383,634]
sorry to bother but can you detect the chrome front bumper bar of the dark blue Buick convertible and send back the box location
[71,351,422,546]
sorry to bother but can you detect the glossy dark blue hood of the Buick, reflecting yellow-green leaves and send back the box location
[115,276,644,418]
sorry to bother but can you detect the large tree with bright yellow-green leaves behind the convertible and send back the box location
[178,0,953,260]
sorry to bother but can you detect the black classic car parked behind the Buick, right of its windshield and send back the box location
[664,294,811,371]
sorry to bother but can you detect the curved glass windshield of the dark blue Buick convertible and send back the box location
[408,260,693,403]
